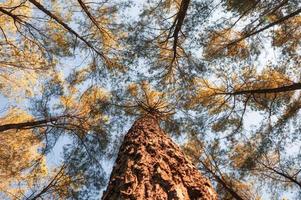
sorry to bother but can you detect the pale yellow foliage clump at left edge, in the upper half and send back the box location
[0,20,54,100]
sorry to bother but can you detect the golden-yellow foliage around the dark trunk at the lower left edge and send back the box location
[0,109,48,197]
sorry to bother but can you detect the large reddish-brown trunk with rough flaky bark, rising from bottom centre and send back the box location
[102,116,217,200]
